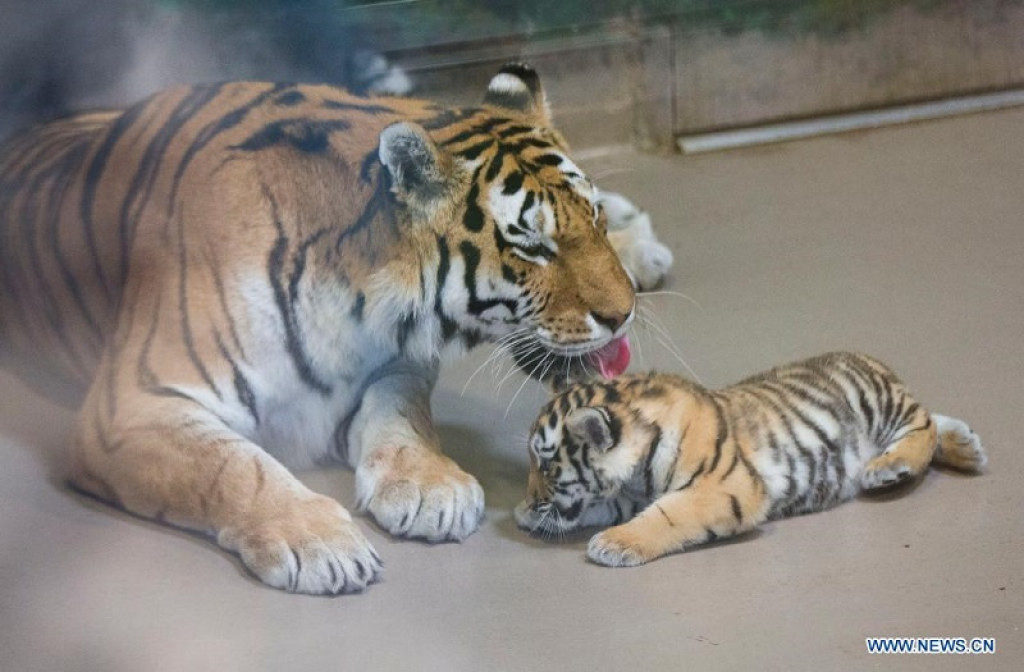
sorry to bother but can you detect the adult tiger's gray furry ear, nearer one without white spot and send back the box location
[377,121,455,207]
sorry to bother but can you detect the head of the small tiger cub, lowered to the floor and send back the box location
[515,377,650,534]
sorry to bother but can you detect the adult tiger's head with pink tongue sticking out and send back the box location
[379,65,635,380]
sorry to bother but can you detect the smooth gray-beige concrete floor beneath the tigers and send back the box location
[0,110,1024,672]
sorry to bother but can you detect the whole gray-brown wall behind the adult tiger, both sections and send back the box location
[393,0,1024,152]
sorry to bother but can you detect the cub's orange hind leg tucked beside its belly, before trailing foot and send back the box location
[860,407,937,490]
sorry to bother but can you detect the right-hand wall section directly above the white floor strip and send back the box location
[674,0,1024,134]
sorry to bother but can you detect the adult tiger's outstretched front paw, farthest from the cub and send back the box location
[217,495,382,595]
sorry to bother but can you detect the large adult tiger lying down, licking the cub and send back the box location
[0,65,634,593]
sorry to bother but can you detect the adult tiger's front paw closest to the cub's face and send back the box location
[355,447,483,542]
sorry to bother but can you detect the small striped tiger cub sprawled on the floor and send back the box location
[515,352,987,566]
